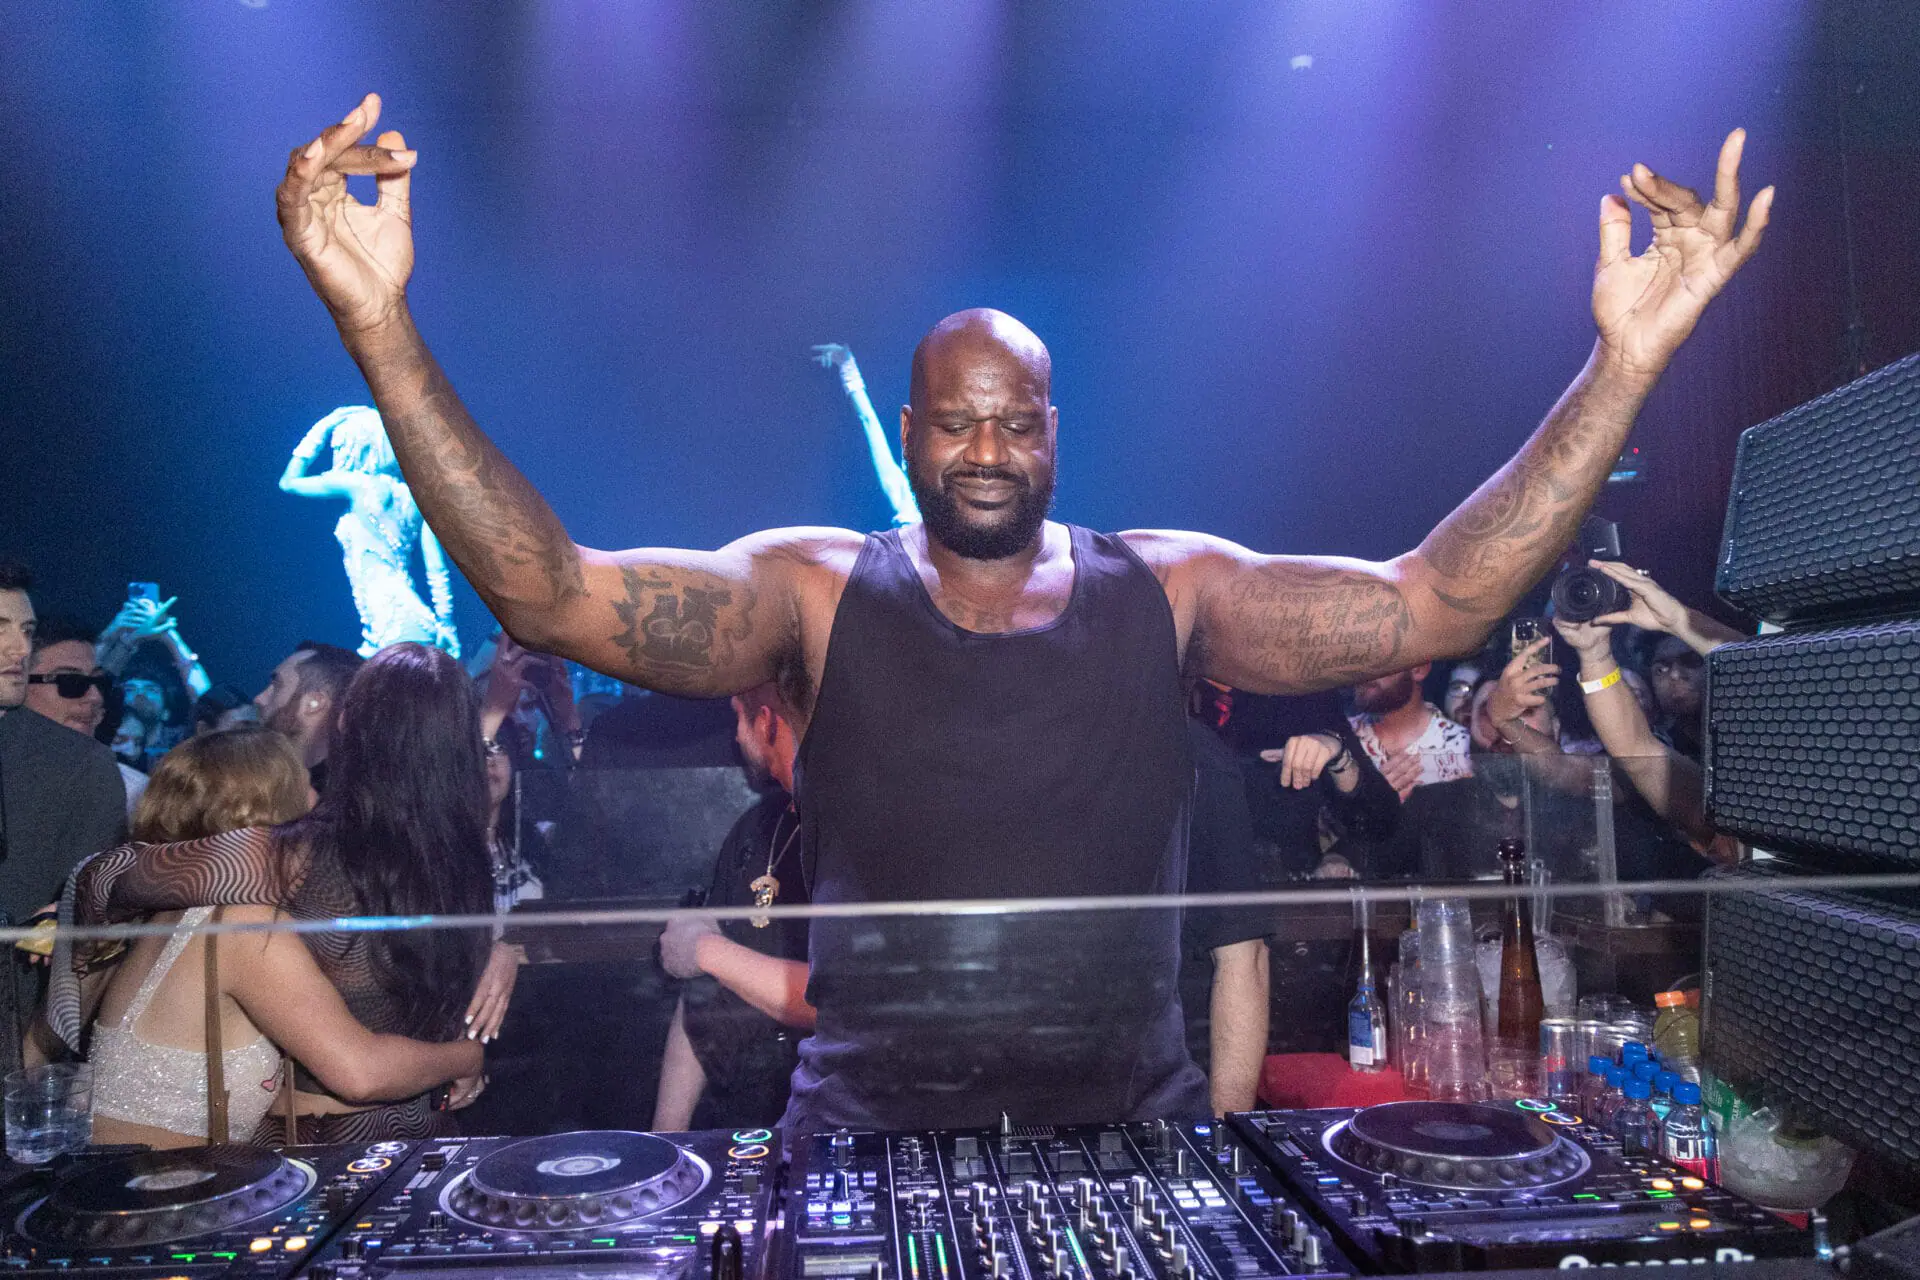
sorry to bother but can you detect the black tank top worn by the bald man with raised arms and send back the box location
[785,526,1208,1132]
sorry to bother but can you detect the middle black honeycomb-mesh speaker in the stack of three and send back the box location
[1705,622,1920,867]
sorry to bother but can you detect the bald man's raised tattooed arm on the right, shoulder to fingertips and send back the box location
[1142,130,1772,693]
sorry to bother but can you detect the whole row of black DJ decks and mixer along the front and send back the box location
[0,1102,1812,1280]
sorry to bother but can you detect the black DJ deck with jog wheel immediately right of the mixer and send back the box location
[1231,1100,1812,1272]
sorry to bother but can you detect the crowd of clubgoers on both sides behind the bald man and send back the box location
[0,537,1741,1146]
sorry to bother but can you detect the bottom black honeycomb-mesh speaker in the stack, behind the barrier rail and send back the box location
[1705,873,1920,1171]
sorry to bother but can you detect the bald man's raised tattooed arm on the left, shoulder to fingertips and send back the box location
[276,94,852,697]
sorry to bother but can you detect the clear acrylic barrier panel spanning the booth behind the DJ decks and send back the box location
[0,871,1920,1165]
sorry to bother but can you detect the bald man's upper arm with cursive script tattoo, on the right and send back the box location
[1188,543,1421,693]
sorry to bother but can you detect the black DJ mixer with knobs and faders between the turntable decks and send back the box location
[787,1121,1350,1280]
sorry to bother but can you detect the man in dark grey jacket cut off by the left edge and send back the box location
[0,564,127,921]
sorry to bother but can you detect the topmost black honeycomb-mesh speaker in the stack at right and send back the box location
[1716,355,1920,624]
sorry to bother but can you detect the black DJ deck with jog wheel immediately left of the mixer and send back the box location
[295,1128,780,1280]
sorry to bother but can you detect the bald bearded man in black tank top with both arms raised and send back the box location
[278,96,1772,1132]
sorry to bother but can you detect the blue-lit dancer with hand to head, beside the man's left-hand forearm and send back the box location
[280,405,461,658]
